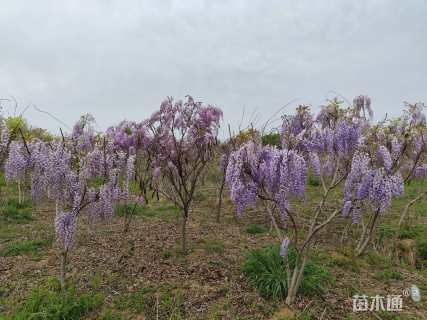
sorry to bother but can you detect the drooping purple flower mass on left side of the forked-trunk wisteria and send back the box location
[226,142,307,218]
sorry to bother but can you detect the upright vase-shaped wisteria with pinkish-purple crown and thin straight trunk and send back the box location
[144,96,222,254]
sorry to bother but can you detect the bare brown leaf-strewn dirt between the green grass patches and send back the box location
[0,180,427,320]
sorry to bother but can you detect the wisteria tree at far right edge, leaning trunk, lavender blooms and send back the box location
[344,101,426,255]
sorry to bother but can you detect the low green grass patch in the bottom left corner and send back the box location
[5,287,103,320]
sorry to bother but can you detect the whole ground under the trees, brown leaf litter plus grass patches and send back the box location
[0,166,427,320]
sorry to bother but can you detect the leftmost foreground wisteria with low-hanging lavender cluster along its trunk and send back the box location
[6,115,133,286]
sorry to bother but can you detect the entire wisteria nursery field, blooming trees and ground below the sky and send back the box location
[0,95,427,320]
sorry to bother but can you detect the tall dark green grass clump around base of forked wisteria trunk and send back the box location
[242,246,334,299]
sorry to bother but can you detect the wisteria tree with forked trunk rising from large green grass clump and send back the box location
[227,102,370,304]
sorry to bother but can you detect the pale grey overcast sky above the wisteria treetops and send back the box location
[0,0,427,132]
